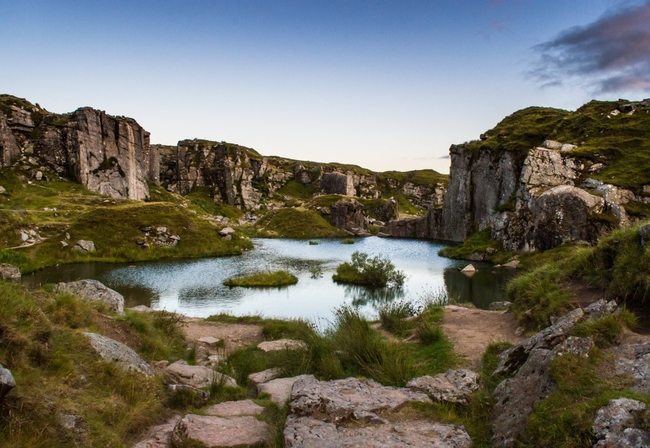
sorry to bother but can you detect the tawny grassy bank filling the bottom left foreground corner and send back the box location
[0,282,190,448]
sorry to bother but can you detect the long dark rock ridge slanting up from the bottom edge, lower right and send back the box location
[492,336,593,447]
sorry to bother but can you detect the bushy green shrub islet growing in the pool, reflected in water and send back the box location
[332,251,406,287]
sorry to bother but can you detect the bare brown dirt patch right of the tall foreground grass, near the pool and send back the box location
[442,305,524,371]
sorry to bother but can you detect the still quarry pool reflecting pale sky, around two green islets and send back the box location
[23,237,513,321]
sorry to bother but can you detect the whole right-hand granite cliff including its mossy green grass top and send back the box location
[382,100,650,251]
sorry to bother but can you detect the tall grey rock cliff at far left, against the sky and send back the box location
[0,97,160,200]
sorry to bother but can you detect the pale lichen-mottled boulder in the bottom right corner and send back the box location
[592,398,650,448]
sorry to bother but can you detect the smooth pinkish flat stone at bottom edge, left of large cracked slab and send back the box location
[172,414,270,448]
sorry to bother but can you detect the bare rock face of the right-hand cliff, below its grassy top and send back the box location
[420,141,646,251]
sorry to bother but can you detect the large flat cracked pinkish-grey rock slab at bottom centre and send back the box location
[284,376,471,448]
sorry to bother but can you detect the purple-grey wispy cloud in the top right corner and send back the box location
[529,1,650,93]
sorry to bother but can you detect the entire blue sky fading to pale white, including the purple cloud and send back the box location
[0,0,650,173]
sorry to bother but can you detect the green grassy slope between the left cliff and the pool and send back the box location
[0,169,252,272]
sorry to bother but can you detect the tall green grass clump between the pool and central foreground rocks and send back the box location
[224,306,458,386]
